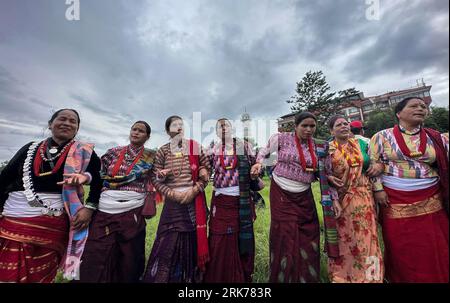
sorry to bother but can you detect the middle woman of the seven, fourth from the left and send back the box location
[204,119,256,283]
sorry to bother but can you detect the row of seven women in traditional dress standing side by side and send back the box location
[0,98,449,283]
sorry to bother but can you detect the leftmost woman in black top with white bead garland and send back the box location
[0,109,101,283]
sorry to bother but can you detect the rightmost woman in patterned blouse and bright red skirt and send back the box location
[370,97,449,283]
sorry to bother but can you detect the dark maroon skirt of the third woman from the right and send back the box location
[269,180,320,283]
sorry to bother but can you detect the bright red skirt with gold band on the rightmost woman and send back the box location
[382,187,449,283]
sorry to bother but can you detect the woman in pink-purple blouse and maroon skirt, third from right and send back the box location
[252,112,320,283]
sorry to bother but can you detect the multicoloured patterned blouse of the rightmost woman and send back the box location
[369,126,449,190]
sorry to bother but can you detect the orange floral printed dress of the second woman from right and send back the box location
[326,139,384,283]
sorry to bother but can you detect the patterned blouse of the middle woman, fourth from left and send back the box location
[207,140,256,188]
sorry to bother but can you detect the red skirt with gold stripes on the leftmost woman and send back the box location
[0,215,69,283]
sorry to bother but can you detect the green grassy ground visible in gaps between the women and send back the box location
[56,178,329,283]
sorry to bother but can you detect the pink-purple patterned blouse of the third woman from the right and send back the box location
[256,133,316,183]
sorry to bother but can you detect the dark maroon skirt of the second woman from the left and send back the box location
[79,207,146,283]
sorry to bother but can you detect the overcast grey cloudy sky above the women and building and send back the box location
[0,0,449,160]
